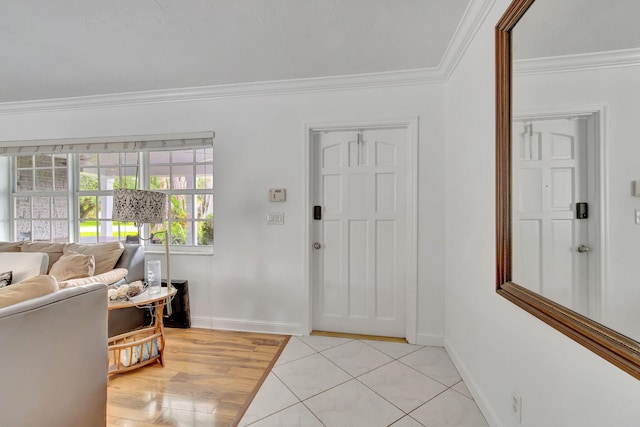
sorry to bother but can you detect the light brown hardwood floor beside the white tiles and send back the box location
[107,328,289,427]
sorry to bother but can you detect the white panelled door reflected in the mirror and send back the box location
[512,117,597,314]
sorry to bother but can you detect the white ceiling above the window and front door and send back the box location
[0,0,470,102]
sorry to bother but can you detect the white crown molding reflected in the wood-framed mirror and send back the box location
[513,48,640,76]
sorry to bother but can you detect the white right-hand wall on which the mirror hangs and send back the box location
[445,0,640,427]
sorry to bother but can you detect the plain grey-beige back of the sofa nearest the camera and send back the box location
[0,283,107,427]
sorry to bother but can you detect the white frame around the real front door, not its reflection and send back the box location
[302,116,418,344]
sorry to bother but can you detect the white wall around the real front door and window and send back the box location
[0,84,444,342]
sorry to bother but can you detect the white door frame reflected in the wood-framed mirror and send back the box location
[513,105,609,322]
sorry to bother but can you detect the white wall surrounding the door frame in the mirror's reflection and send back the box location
[514,66,640,340]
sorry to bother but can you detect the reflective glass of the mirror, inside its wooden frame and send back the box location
[511,0,640,341]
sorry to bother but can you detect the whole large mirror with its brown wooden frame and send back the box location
[495,0,640,379]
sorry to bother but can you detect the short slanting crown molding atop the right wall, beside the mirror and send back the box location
[438,0,495,81]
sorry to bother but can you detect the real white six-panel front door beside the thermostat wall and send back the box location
[311,128,415,337]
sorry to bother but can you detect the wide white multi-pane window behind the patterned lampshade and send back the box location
[11,139,213,247]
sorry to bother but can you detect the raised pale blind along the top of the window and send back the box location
[0,132,215,156]
